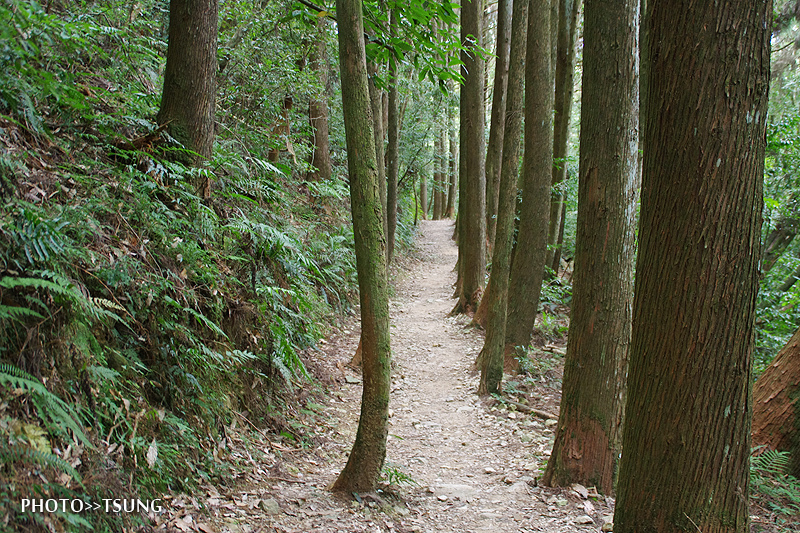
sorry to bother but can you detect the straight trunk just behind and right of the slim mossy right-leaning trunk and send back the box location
[506,0,554,348]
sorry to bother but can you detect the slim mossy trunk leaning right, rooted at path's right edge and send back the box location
[476,0,528,394]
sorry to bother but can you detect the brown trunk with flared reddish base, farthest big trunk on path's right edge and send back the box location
[453,0,486,313]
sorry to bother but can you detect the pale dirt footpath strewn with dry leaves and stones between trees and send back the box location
[150,221,792,533]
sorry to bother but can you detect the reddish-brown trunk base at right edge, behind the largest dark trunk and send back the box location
[753,329,800,478]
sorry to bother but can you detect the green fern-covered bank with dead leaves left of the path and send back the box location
[0,0,368,531]
